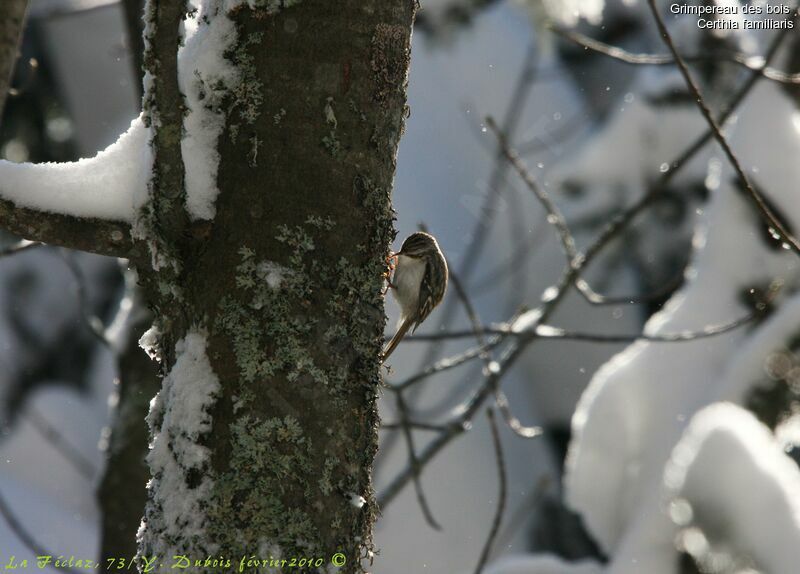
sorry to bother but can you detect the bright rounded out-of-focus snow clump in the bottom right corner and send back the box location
[665,403,800,574]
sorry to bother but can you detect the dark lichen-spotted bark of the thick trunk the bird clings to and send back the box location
[137,0,415,572]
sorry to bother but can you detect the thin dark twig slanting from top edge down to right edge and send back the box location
[648,0,800,256]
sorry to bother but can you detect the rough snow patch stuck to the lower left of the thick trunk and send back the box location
[138,331,220,554]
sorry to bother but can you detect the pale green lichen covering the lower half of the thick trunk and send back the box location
[215,210,392,564]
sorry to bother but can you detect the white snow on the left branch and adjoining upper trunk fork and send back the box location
[0,0,250,223]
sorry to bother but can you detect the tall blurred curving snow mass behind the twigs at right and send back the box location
[565,77,800,574]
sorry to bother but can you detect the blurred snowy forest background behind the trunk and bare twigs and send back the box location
[0,0,800,574]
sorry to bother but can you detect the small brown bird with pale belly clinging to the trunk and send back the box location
[381,231,447,361]
